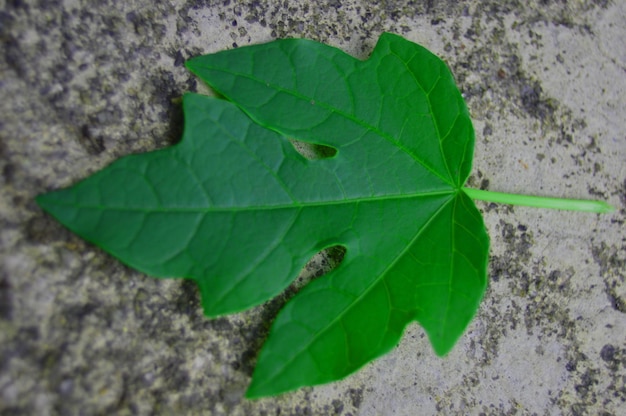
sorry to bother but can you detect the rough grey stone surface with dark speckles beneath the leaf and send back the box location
[0,0,626,415]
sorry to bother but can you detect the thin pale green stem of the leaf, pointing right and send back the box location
[463,188,615,213]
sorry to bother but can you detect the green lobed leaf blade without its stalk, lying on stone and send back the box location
[37,34,489,397]
